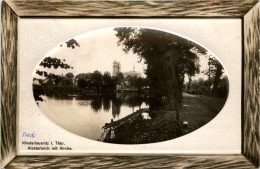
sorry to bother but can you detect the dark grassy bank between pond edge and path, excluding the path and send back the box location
[108,111,188,144]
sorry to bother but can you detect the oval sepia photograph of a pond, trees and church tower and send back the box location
[32,27,229,144]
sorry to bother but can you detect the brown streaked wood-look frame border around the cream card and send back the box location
[1,0,260,168]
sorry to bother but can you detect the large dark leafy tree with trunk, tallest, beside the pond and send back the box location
[115,27,205,116]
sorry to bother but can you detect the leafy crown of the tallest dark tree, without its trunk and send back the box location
[114,27,202,84]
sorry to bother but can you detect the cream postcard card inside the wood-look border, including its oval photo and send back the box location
[17,19,241,154]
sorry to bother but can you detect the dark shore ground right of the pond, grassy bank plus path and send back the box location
[104,94,225,144]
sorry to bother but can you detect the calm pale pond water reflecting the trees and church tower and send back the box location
[39,93,149,140]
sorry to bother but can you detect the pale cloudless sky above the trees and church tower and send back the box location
[35,28,222,82]
